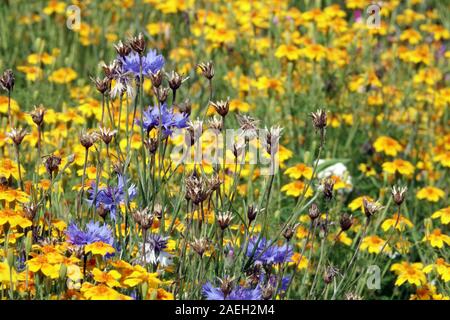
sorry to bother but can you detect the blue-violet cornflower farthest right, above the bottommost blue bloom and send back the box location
[247,237,293,264]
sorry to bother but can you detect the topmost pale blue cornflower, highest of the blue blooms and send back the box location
[118,50,165,77]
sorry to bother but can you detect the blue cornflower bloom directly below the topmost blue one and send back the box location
[136,103,189,136]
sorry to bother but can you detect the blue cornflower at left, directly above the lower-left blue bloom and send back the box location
[87,175,137,221]
